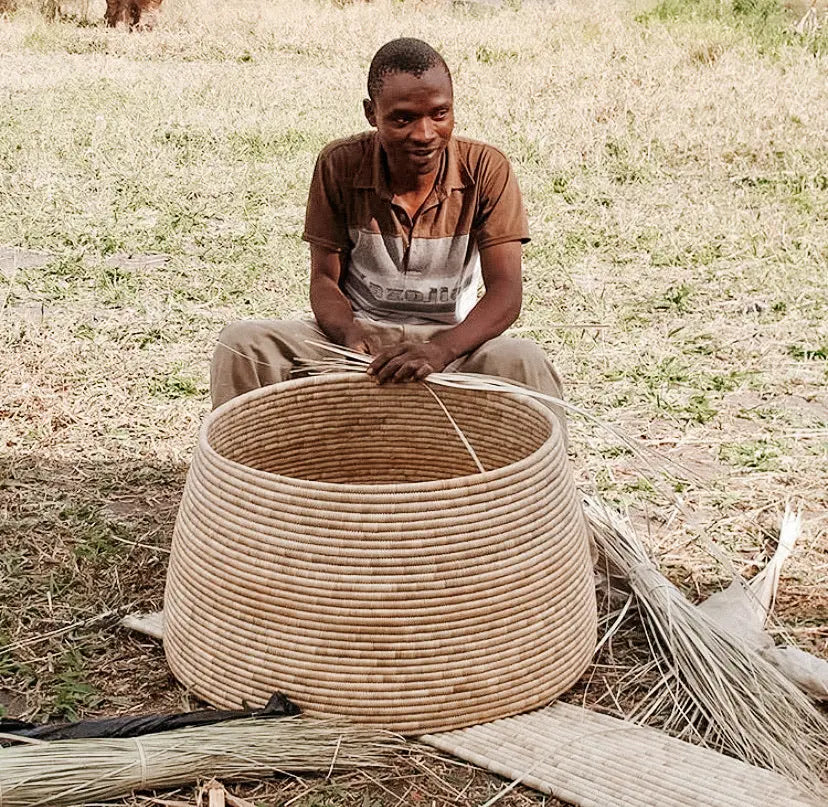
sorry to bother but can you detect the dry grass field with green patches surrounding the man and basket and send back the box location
[0,0,828,807]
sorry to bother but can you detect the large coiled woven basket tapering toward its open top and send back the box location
[165,374,596,734]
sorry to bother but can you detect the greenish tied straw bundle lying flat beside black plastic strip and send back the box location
[0,717,401,807]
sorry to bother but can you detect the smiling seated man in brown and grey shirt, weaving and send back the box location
[210,39,564,436]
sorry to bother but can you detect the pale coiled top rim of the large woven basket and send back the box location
[198,372,561,495]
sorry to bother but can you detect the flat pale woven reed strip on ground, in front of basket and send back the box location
[420,703,819,807]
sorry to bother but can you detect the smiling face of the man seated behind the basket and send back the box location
[365,65,454,174]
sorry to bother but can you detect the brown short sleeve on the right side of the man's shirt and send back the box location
[475,149,529,249]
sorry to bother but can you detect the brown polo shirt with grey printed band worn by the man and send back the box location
[302,131,529,325]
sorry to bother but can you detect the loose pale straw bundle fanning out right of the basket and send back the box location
[586,499,828,797]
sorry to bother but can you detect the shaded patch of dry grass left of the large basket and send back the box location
[0,452,189,720]
